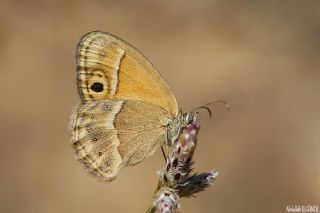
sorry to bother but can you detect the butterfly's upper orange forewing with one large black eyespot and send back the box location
[76,31,179,115]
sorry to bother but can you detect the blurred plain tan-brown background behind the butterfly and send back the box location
[0,0,320,213]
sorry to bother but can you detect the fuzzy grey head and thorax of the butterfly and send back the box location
[167,111,197,146]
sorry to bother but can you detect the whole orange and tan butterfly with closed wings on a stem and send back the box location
[70,31,202,181]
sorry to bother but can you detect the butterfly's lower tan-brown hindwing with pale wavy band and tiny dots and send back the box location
[70,100,172,181]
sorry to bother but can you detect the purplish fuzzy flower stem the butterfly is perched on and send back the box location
[147,122,218,213]
